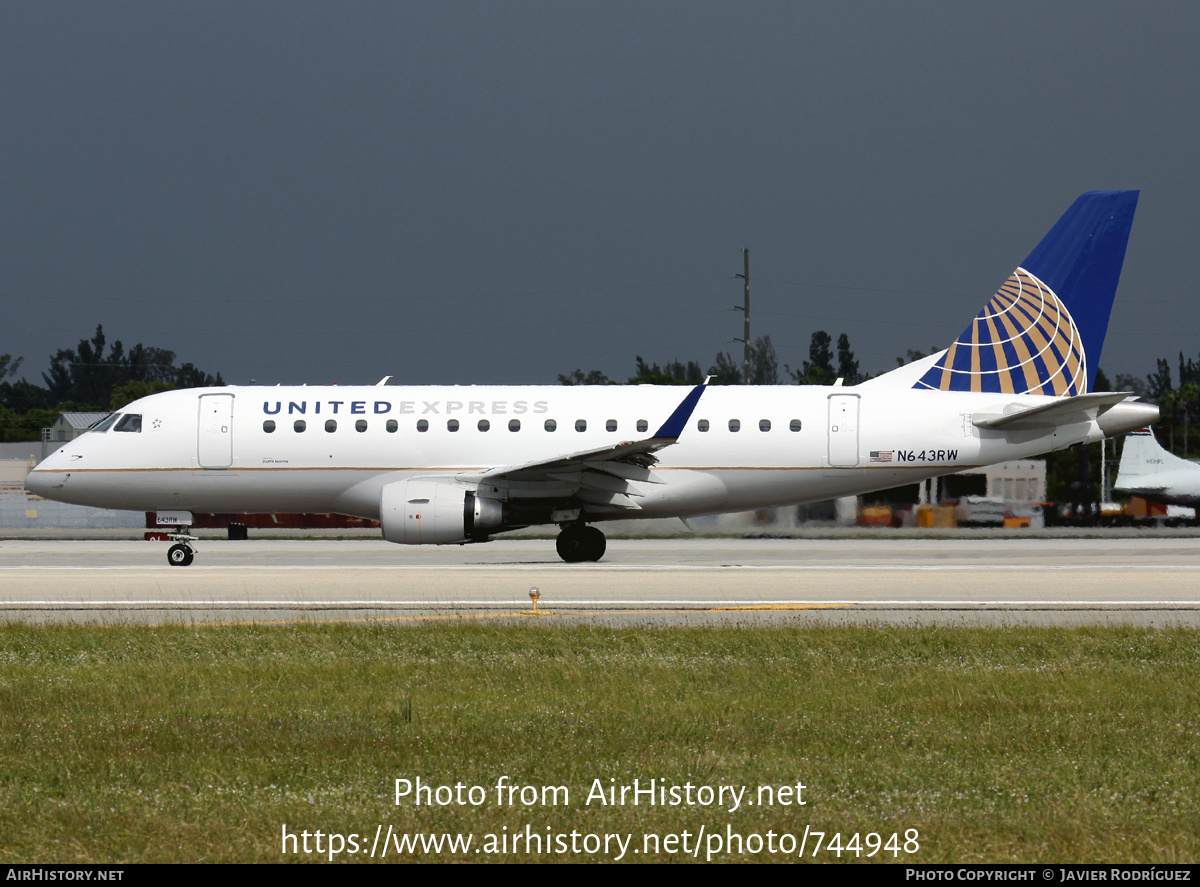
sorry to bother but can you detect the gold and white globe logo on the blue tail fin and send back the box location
[913,268,1087,397]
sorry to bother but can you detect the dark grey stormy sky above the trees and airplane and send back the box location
[0,0,1200,384]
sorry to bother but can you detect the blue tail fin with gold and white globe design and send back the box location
[914,191,1139,396]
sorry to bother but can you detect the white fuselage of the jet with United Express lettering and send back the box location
[26,383,1146,520]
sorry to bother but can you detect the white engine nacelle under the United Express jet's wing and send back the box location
[379,479,504,545]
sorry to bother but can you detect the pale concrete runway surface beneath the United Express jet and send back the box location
[0,538,1200,625]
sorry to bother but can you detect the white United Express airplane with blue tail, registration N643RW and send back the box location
[25,191,1158,565]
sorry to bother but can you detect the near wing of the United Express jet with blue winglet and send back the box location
[475,380,708,510]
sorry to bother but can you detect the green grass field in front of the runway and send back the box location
[0,623,1200,863]
